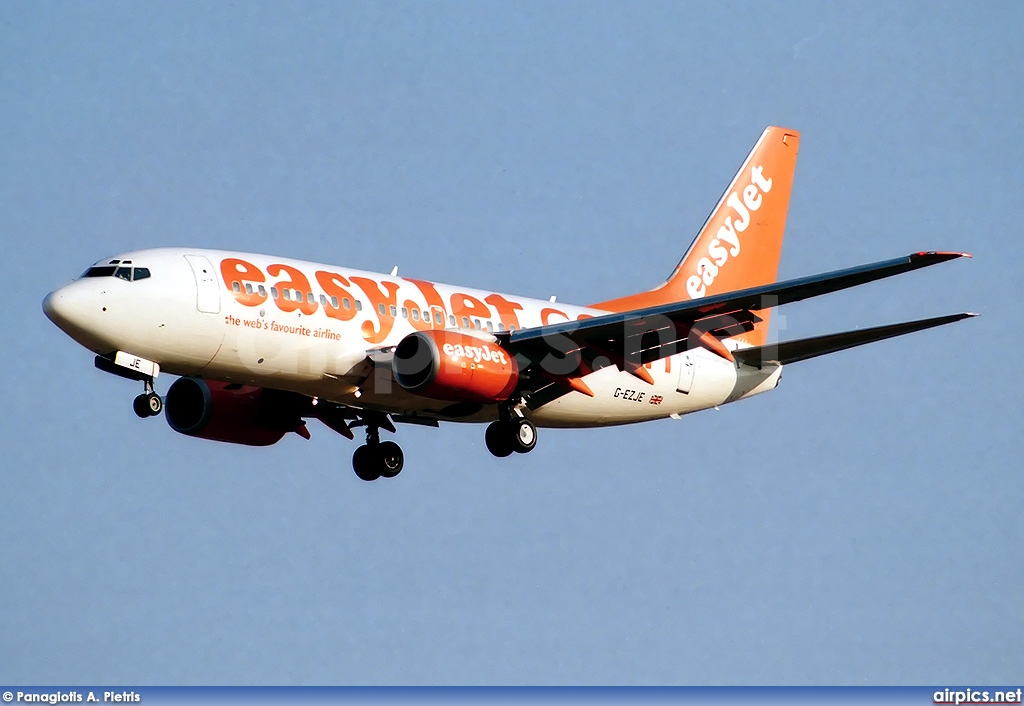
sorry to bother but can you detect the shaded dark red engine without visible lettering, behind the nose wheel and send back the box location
[164,377,291,446]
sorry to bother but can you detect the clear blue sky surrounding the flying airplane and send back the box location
[0,2,1024,684]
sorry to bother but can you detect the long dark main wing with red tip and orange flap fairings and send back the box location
[498,252,970,399]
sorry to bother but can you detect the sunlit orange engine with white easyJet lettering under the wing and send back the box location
[393,329,519,404]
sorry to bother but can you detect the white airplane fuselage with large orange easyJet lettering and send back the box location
[44,248,781,426]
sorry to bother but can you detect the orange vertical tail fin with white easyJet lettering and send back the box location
[594,127,800,345]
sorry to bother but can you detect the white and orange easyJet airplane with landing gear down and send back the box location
[43,126,976,481]
